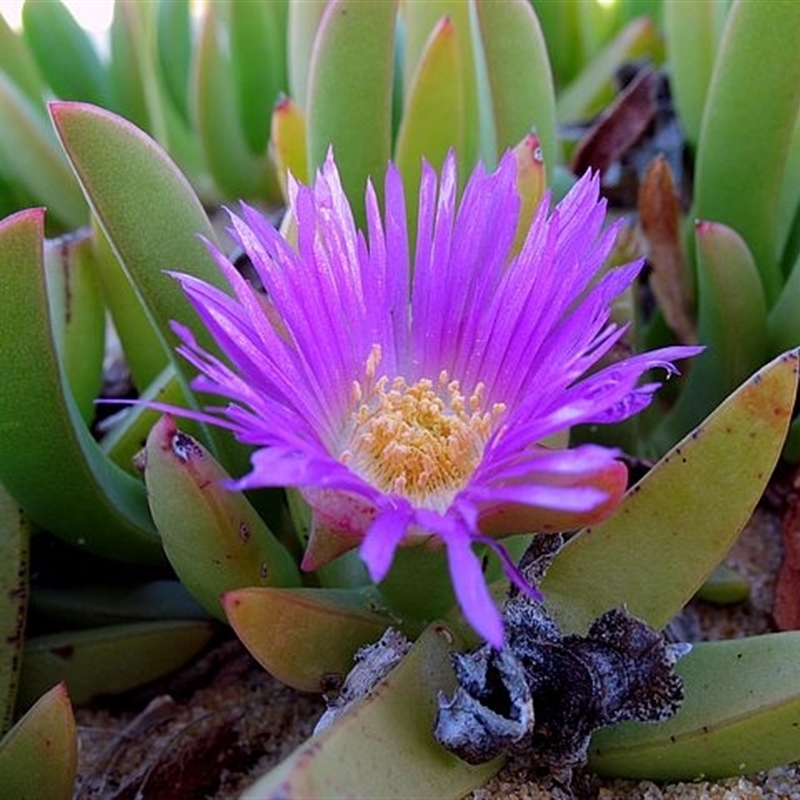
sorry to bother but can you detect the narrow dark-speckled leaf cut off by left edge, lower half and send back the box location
[0,486,30,736]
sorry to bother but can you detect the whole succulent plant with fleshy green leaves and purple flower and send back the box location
[0,0,800,797]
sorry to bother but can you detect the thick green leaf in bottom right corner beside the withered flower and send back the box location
[589,632,800,780]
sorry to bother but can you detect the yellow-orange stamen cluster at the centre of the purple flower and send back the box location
[341,347,505,510]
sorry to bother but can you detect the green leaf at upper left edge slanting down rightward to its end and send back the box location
[0,72,88,228]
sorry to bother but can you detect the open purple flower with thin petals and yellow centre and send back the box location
[167,154,699,646]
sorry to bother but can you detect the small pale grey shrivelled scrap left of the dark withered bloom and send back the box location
[314,628,411,734]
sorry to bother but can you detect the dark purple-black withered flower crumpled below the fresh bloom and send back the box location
[435,536,690,771]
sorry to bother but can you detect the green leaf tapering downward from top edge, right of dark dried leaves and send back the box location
[662,0,728,147]
